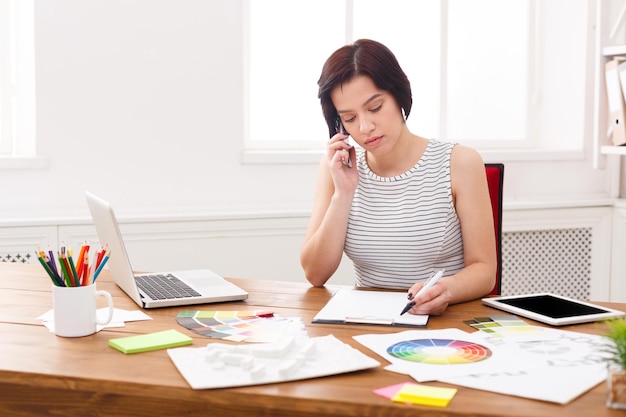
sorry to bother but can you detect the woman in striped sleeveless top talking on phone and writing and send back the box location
[300,39,497,315]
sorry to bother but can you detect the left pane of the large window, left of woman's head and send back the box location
[249,0,347,149]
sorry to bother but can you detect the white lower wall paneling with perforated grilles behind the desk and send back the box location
[0,201,626,301]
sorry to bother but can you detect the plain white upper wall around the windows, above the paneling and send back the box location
[0,0,608,288]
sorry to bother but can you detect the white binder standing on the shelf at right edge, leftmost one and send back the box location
[605,58,626,146]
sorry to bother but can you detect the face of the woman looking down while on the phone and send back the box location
[330,75,404,155]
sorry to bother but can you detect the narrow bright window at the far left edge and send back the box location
[0,0,35,163]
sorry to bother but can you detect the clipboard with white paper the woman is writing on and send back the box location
[313,289,428,327]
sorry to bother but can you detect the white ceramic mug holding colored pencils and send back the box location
[52,284,113,337]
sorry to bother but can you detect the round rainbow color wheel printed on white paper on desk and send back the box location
[387,339,492,365]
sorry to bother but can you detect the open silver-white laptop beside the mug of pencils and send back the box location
[85,192,248,308]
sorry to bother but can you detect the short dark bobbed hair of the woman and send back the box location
[317,39,413,136]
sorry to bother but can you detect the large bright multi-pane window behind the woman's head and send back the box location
[246,0,587,159]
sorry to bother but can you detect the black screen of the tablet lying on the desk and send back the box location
[498,295,608,319]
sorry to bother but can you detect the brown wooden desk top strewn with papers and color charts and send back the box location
[0,263,626,417]
